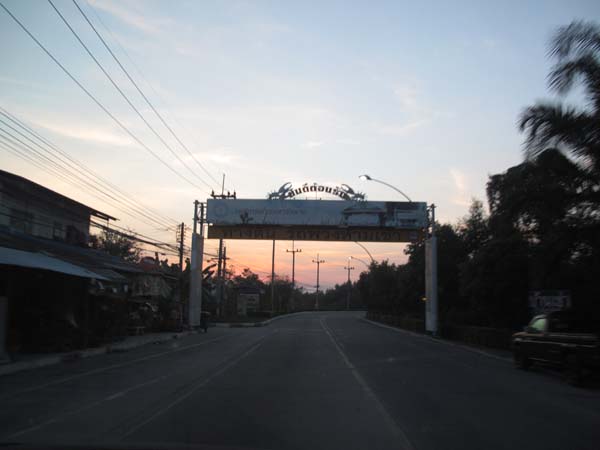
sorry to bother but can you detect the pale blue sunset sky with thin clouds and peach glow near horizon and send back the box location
[0,0,600,284]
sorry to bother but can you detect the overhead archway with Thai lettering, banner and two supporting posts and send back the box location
[189,183,437,335]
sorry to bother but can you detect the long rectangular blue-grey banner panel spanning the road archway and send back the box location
[207,199,427,242]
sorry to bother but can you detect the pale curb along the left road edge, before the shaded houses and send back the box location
[0,331,194,376]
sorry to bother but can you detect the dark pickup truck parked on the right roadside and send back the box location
[512,311,600,385]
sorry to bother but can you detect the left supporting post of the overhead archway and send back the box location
[187,200,204,327]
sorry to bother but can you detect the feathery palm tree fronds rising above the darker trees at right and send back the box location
[519,21,600,176]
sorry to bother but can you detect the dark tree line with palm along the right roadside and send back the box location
[356,22,600,328]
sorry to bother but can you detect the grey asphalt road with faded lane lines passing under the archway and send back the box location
[0,312,600,450]
